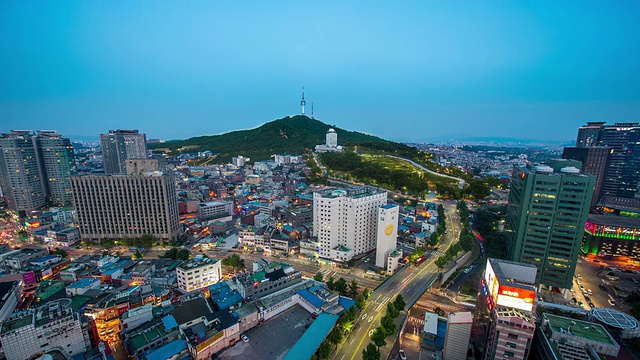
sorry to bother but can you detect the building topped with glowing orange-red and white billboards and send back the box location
[478,258,536,360]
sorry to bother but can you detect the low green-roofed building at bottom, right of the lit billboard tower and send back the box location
[530,313,620,360]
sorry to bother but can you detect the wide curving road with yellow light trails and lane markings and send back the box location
[333,202,461,360]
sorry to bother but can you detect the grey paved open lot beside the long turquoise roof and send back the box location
[220,305,313,360]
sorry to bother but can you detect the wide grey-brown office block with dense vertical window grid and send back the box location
[71,172,180,239]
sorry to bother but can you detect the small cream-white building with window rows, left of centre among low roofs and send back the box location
[176,255,222,292]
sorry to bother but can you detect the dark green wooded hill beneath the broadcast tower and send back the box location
[149,115,392,161]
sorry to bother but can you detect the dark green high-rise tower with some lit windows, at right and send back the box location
[505,160,595,289]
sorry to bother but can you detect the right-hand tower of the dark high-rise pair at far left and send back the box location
[33,130,78,205]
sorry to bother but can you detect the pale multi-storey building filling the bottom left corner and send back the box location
[0,299,88,360]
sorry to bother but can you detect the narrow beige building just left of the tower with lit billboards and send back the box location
[442,311,473,360]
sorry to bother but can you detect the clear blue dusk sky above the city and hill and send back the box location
[0,1,640,141]
